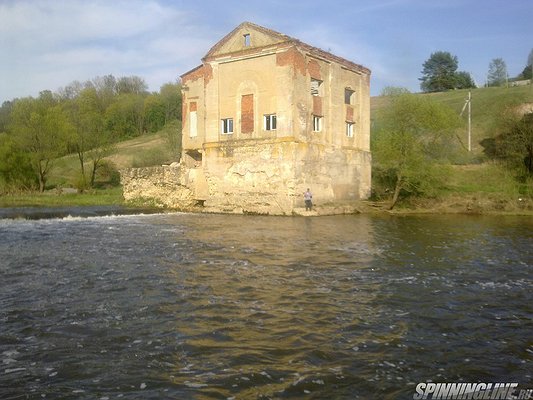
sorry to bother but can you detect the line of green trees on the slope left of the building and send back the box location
[0,75,181,193]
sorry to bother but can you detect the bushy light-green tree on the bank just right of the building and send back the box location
[372,94,460,209]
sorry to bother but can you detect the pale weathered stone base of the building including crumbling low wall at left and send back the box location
[121,140,370,215]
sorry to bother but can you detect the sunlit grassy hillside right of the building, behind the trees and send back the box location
[371,86,533,209]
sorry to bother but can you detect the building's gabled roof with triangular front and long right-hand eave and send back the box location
[202,22,370,74]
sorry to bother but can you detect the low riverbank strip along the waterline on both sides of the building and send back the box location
[0,188,533,216]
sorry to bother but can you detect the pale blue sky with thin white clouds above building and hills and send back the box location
[0,0,533,103]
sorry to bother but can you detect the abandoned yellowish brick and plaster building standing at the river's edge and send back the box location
[121,22,371,214]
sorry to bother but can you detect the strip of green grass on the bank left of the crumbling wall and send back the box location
[0,187,124,207]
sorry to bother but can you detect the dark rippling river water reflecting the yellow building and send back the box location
[0,214,533,400]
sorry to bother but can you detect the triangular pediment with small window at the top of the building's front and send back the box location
[204,22,293,59]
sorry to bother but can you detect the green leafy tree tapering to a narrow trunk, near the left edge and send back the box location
[10,91,72,192]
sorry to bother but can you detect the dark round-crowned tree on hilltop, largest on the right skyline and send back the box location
[419,51,458,92]
